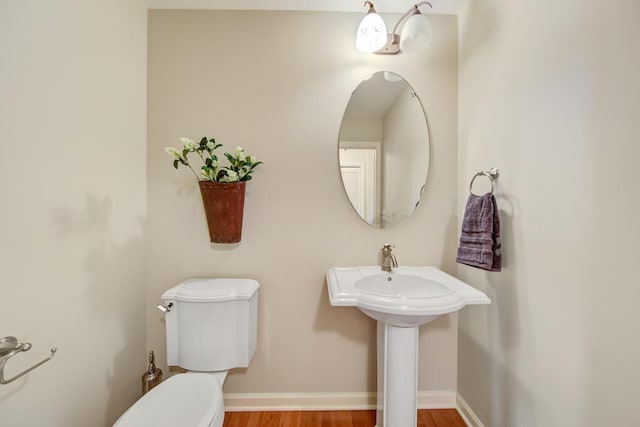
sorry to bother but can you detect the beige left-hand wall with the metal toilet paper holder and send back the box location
[0,0,146,427]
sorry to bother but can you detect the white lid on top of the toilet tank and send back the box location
[161,278,260,302]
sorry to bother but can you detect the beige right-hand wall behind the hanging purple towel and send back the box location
[458,0,640,427]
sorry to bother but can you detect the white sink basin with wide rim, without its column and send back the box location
[327,266,491,326]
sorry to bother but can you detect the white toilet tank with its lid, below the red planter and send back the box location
[161,279,260,372]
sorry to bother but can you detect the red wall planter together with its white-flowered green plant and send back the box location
[165,136,262,243]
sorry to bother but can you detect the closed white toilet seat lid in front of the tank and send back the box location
[113,373,224,427]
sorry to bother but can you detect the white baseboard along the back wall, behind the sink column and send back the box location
[224,391,456,412]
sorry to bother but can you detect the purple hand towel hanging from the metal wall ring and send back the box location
[456,193,502,271]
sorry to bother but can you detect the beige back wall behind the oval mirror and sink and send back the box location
[147,11,457,393]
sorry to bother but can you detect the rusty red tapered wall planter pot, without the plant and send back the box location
[198,181,246,243]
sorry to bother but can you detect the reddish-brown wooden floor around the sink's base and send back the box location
[223,409,466,427]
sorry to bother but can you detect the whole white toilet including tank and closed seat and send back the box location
[114,279,260,427]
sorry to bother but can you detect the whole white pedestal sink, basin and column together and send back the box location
[327,267,491,427]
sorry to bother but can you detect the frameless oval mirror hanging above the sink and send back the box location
[338,71,429,228]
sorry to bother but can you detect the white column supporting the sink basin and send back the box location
[376,321,418,427]
